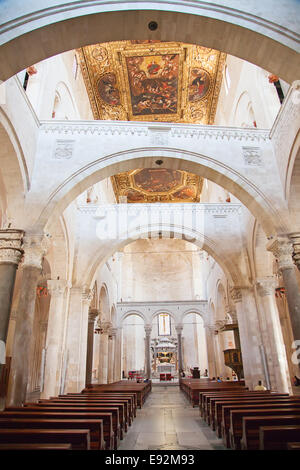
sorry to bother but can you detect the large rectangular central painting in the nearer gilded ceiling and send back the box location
[126,54,179,116]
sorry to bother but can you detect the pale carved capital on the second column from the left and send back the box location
[23,234,50,269]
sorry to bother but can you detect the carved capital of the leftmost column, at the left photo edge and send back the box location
[0,229,24,265]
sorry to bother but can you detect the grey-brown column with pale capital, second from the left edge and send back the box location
[8,236,46,406]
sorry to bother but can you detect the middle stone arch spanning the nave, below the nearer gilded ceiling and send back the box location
[42,148,288,234]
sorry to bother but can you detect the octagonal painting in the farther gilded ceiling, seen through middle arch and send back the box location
[134,168,182,193]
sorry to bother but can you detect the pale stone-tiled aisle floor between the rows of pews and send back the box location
[119,385,225,450]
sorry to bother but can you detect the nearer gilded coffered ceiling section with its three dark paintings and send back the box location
[77,41,225,124]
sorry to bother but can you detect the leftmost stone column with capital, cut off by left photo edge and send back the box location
[0,229,24,377]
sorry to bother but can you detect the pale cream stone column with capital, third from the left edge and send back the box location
[42,280,67,398]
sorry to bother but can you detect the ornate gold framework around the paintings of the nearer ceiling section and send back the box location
[76,41,226,125]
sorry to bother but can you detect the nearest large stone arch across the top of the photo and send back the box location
[0,5,299,82]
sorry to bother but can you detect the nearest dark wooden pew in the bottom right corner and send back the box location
[259,425,300,450]
